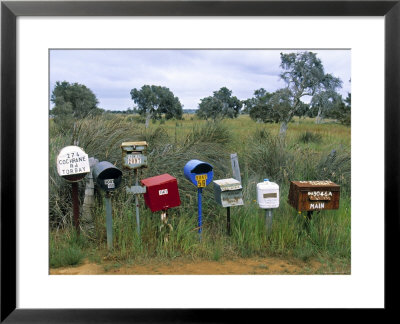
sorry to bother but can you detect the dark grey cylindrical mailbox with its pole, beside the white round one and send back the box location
[92,161,122,250]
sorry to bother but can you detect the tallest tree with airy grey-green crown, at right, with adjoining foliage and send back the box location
[246,52,342,136]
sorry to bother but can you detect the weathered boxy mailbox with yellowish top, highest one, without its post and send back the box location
[121,141,147,169]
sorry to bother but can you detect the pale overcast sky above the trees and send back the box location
[50,50,351,110]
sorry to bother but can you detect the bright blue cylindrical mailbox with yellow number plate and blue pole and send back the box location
[183,160,214,238]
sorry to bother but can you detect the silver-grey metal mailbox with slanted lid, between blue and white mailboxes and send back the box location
[213,178,243,207]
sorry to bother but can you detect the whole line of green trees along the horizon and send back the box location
[50,51,351,136]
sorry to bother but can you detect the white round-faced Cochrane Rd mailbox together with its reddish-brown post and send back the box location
[57,145,90,234]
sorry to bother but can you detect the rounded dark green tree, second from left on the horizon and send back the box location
[130,85,183,126]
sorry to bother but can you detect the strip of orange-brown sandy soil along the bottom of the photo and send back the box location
[50,258,350,275]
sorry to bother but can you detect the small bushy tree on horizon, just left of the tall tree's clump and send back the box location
[196,87,243,120]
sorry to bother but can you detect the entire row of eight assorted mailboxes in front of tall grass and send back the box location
[57,145,340,243]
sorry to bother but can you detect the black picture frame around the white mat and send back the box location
[0,0,400,323]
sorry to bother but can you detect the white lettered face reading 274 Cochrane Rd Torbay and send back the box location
[57,146,90,176]
